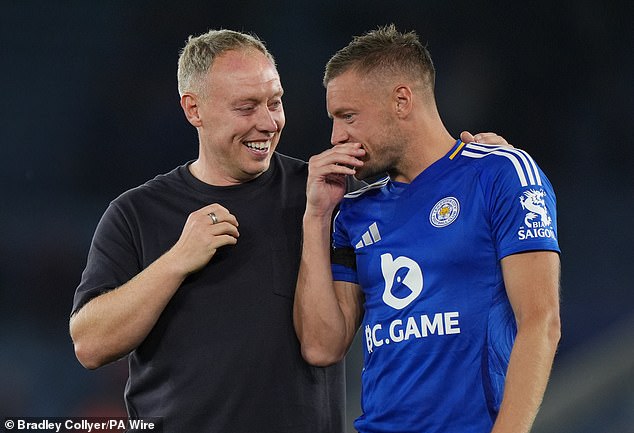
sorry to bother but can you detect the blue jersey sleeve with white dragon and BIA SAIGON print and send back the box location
[483,150,560,260]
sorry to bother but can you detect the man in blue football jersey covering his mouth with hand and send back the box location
[294,25,560,433]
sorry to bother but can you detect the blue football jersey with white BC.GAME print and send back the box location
[332,141,559,433]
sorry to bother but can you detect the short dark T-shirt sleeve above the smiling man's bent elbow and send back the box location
[71,202,141,314]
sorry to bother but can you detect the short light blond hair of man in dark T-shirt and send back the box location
[177,29,275,96]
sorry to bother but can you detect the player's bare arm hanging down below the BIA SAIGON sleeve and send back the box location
[492,251,561,433]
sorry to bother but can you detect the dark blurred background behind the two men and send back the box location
[0,0,634,433]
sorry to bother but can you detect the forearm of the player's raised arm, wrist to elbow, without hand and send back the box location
[294,215,355,365]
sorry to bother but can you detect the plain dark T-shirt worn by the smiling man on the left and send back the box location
[73,153,345,433]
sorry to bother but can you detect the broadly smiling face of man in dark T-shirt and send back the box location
[195,49,286,185]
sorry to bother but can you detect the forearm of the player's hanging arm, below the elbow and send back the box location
[492,314,560,433]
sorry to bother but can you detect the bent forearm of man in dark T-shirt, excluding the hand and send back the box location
[70,253,186,369]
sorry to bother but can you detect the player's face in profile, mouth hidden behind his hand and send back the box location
[326,70,405,179]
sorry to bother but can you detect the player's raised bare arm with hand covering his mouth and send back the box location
[293,144,363,366]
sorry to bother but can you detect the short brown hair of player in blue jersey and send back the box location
[323,24,436,91]
